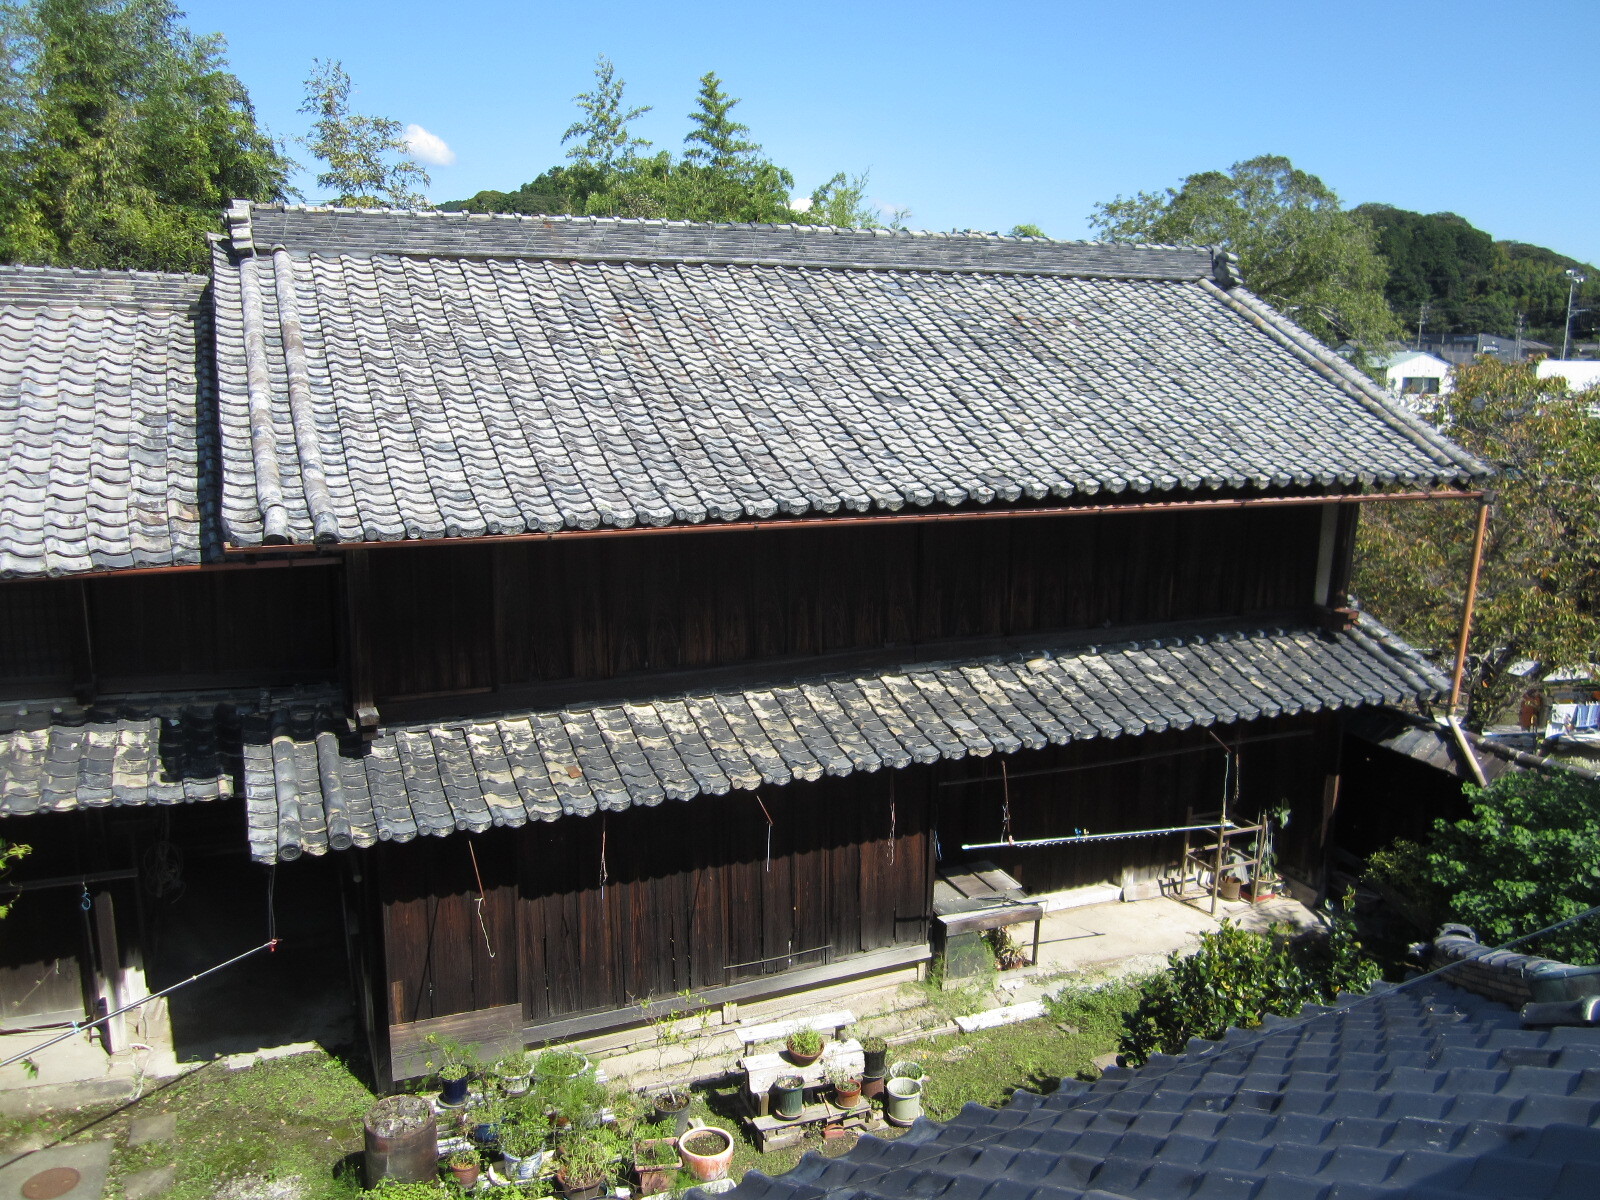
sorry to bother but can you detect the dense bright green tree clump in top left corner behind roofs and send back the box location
[0,0,293,270]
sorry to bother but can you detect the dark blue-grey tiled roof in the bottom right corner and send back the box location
[730,982,1600,1200]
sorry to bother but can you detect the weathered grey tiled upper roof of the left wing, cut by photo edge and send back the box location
[0,267,221,579]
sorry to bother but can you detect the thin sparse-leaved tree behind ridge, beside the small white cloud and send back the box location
[299,59,429,208]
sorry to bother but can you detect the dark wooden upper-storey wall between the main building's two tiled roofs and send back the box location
[373,507,1320,701]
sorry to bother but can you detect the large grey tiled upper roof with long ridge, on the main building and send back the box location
[214,203,1486,546]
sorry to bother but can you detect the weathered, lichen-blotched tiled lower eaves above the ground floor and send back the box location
[0,626,1445,861]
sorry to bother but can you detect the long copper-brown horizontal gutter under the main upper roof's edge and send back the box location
[226,490,1483,555]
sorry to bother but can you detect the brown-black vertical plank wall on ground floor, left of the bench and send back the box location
[381,771,931,1024]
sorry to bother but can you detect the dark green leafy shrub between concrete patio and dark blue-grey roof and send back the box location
[1117,915,1378,1066]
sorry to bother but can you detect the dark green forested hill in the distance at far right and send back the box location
[1355,205,1600,346]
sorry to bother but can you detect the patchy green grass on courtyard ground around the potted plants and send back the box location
[0,981,1139,1200]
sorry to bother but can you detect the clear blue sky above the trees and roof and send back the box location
[187,0,1600,262]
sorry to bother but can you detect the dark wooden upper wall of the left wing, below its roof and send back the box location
[0,566,339,696]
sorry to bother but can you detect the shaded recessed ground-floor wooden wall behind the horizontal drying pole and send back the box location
[936,715,1338,893]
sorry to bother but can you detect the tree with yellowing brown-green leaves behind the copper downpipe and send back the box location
[1354,357,1600,728]
